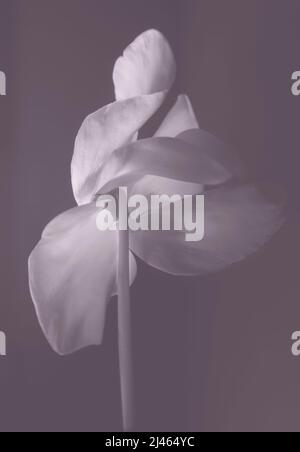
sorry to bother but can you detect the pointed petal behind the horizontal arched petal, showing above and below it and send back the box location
[132,95,203,196]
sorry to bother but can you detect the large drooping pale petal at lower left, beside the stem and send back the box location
[29,205,136,355]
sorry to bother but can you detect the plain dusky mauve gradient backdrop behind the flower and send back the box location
[0,0,300,432]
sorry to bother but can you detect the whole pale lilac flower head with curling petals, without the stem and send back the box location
[29,30,283,354]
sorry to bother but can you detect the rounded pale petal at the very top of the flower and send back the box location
[113,30,176,100]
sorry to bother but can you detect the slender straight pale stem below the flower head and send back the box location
[118,231,134,432]
